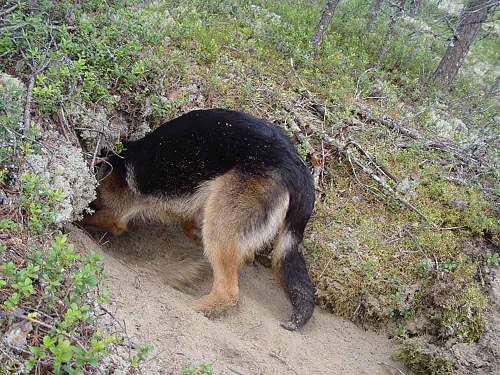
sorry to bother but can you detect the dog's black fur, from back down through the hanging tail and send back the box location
[110,109,314,329]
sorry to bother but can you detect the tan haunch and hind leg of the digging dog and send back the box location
[196,173,288,312]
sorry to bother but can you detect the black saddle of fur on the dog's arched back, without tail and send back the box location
[113,109,309,196]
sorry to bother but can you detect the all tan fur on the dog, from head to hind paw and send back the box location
[84,169,289,314]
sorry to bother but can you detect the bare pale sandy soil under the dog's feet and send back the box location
[71,225,401,375]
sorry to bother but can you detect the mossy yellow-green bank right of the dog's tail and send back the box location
[307,133,498,342]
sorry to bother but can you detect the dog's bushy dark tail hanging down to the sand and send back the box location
[273,171,315,331]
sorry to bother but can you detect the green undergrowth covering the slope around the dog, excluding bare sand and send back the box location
[0,0,499,373]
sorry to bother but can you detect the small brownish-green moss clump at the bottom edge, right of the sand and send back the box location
[394,340,453,375]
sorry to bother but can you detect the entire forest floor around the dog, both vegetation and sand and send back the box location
[0,0,500,374]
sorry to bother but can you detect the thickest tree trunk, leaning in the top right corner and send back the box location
[433,0,498,86]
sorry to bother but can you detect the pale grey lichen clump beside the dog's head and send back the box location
[23,131,97,225]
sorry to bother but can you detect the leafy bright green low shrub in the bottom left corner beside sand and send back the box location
[0,234,117,374]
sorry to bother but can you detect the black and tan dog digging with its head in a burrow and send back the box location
[84,109,314,330]
